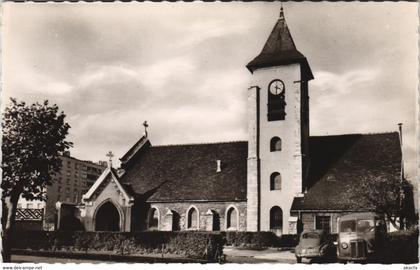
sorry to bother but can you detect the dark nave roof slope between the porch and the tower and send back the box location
[121,142,248,201]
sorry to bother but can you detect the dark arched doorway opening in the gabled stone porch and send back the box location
[95,202,120,232]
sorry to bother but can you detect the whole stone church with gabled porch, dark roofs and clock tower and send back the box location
[77,7,402,235]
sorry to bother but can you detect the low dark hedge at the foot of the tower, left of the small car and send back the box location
[222,231,298,249]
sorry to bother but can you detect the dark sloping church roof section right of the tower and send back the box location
[292,132,402,211]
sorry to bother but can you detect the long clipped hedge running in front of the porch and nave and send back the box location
[13,231,224,261]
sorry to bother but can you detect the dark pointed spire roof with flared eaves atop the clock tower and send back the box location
[246,10,314,81]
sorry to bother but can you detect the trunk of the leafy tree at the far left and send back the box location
[1,195,20,262]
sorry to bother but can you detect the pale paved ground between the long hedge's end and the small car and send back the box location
[223,247,296,263]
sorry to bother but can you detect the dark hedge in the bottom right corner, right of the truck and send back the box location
[384,228,419,264]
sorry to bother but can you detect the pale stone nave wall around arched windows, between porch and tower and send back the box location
[148,202,246,231]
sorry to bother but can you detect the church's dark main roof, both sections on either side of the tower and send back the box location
[120,132,401,206]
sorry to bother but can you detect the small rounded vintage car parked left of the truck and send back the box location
[295,230,336,263]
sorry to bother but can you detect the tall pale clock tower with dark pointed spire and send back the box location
[247,7,313,234]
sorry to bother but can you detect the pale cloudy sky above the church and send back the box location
[1,2,418,182]
